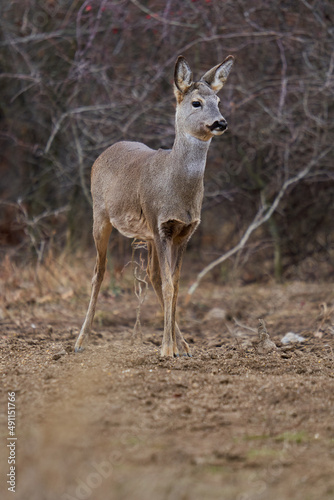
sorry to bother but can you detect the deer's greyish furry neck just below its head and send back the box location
[171,130,211,179]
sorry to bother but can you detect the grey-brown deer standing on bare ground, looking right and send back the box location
[75,55,234,357]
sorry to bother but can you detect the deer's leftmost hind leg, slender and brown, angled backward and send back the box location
[74,219,112,352]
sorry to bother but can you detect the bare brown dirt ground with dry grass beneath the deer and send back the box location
[0,265,334,500]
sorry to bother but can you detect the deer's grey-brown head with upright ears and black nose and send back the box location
[174,56,234,141]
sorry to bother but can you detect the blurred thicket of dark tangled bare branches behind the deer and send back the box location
[0,0,334,283]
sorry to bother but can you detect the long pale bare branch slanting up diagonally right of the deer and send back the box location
[185,146,333,304]
